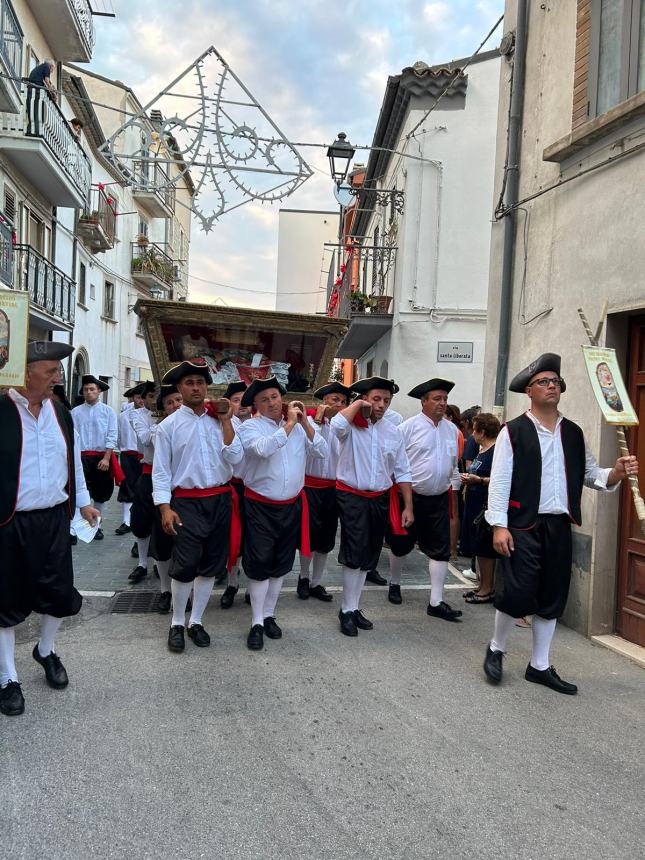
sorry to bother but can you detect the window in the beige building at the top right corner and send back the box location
[588,0,645,116]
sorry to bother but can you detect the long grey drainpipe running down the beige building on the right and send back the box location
[495,0,529,413]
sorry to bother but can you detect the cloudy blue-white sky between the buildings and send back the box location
[91,0,504,308]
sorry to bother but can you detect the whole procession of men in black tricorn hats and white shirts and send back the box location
[0,341,638,716]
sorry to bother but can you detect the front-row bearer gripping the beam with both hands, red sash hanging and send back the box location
[238,376,327,651]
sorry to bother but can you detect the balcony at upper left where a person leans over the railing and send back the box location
[0,84,92,209]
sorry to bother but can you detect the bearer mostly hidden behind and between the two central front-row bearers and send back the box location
[298,382,352,603]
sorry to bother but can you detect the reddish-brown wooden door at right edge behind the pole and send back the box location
[616,317,645,646]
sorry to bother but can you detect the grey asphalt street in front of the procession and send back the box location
[0,589,645,860]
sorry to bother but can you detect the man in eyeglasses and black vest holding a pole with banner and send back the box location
[484,353,638,695]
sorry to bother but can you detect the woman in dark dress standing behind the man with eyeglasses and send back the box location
[461,412,500,603]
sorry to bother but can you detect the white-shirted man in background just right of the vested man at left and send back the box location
[72,374,118,540]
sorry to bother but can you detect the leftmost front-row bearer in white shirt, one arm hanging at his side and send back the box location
[152,358,243,652]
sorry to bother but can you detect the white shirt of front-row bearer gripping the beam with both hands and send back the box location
[238,415,328,502]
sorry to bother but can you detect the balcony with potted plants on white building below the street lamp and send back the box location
[328,245,397,359]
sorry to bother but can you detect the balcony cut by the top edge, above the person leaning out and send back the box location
[27,0,94,63]
